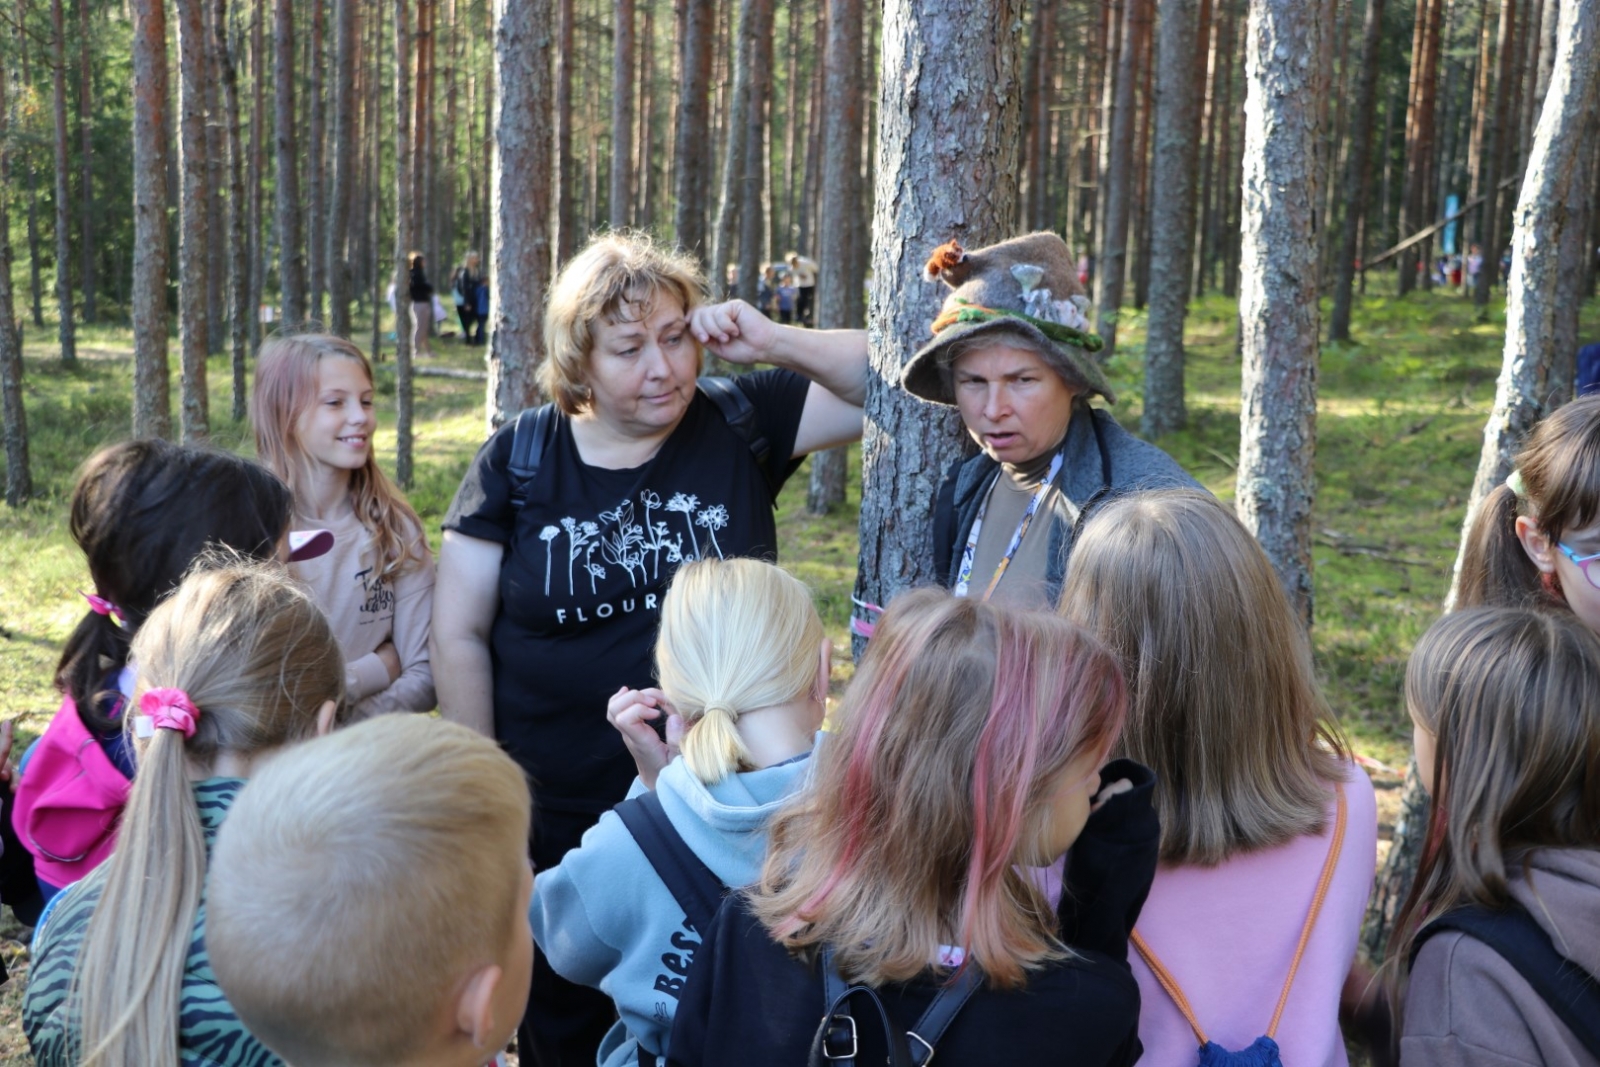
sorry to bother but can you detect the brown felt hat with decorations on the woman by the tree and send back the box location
[901,232,1117,405]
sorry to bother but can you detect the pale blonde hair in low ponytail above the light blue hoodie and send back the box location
[656,558,827,785]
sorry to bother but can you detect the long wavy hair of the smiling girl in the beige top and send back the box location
[250,333,427,577]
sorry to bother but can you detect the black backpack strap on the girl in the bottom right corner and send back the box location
[1411,904,1600,1057]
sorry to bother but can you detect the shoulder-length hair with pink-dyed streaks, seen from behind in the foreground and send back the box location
[752,590,1126,987]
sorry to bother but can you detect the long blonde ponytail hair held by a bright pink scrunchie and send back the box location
[70,563,344,1067]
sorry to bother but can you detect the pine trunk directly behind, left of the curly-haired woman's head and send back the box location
[488,0,554,426]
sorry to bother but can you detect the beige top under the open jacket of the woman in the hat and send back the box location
[958,448,1077,611]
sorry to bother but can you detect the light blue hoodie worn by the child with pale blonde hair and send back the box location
[528,757,811,1067]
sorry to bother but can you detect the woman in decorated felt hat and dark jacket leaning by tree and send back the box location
[901,232,1200,606]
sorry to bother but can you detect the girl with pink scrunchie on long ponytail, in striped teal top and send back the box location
[22,561,344,1067]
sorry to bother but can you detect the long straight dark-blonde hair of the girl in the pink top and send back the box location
[1061,490,1346,865]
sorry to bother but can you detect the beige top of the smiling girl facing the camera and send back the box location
[290,514,437,718]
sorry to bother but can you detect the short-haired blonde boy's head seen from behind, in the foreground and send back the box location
[205,715,533,1067]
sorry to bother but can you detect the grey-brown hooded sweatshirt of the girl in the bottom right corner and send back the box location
[1400,848,1600,1067]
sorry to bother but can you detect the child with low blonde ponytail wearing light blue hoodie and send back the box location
[531,558,830,1067]
